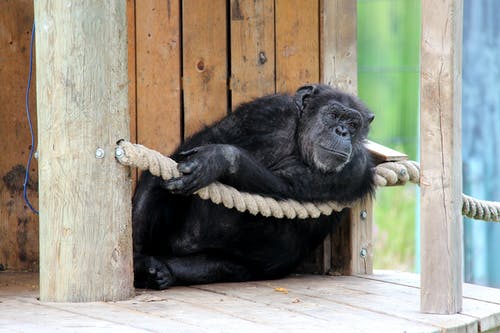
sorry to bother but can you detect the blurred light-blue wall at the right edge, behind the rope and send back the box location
[462,0,500,287]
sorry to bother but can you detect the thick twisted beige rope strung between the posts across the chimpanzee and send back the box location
[115,141,500,221]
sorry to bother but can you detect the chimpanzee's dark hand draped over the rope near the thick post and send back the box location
[164,144,239,195]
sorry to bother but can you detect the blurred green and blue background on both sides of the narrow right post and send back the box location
[358,0,500,288]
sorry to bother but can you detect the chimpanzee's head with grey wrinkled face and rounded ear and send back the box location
[294,84,374,172]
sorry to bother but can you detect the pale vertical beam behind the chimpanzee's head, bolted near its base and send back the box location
[320,0,373,274]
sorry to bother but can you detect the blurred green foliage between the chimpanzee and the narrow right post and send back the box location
[358,0,420,269]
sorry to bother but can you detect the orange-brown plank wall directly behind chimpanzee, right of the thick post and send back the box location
[128,0,320,154]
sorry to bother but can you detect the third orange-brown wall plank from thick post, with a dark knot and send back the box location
[230,0,275,108]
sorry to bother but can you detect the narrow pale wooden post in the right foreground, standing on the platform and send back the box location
[420,0,463,314]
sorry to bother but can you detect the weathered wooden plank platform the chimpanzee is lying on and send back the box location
[0,271,500,333]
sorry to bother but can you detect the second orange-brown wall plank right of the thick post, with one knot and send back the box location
[182,0,228,137]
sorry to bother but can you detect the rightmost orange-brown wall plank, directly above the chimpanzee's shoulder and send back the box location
[275,0,320,93]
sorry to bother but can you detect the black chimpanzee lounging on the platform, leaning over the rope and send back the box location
[132,84,374,289]
